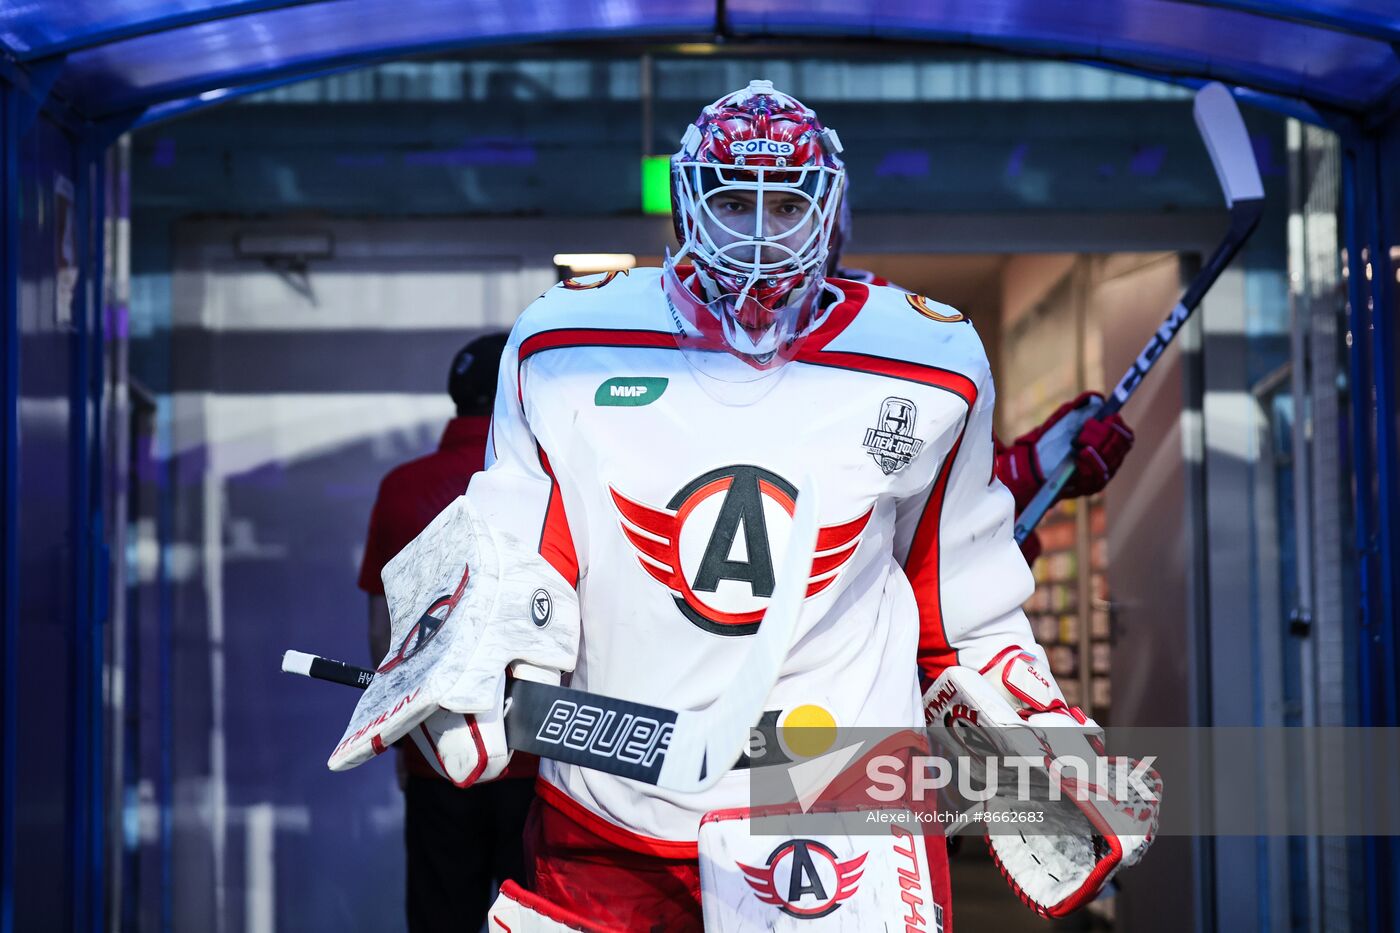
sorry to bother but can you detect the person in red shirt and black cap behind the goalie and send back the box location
[360,333,538,933]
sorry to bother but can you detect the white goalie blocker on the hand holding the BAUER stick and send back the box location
[328,496,580,786]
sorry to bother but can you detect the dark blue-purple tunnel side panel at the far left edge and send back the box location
[14,112,77,930]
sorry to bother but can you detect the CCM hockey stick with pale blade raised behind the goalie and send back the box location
[1016,81,1264,544]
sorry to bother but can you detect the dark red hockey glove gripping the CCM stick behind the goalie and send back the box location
[997,392,1134,514]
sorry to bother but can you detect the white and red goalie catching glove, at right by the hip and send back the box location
[924,649,1162,918]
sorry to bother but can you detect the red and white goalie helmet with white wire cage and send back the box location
[666,81,846,368]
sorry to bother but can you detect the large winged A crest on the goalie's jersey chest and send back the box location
[609,464,874,635]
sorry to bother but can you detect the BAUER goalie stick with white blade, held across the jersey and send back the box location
[281,476,818,793]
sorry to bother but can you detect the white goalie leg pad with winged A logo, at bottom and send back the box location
[700,807,952,933]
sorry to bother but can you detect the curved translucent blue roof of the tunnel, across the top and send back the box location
[0,0,1400,122]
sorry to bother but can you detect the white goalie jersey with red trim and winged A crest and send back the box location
[468,269,1036,856]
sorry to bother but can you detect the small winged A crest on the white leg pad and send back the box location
[735,839,869,920]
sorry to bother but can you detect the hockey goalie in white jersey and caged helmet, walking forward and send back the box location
[332,81,1155,930]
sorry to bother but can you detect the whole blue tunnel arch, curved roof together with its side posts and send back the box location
[0,0,1400,933]
